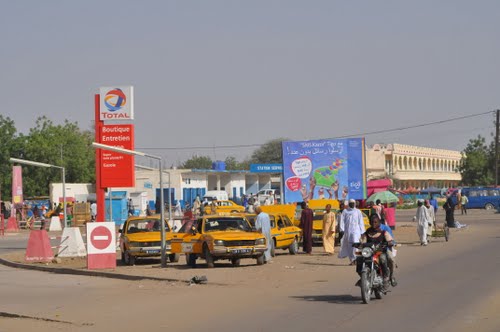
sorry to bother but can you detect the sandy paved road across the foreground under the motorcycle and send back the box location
[0,212,500,332]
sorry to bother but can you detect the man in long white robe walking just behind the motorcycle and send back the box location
[339,199,365,265]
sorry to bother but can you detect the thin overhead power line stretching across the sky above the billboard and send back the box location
[137,111,495,151]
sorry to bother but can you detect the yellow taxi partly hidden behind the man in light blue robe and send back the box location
[247,213,302,257]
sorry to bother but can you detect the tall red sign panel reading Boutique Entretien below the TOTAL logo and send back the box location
[99,124,135,188]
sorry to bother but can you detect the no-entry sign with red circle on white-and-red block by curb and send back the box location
[87,222,116,269]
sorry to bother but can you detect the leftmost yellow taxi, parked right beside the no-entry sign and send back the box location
[120,215,179,265]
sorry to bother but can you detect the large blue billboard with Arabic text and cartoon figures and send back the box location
[282,138,366,203]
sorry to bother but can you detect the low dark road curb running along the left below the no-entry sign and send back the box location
[0,257,190,284]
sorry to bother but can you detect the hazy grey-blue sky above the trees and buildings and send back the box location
[0,0,500,166]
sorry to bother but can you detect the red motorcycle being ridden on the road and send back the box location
[353,243,395,304]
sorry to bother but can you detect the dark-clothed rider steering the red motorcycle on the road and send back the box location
[356,213,394,289]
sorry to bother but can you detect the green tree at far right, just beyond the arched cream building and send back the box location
[459,135,494,186]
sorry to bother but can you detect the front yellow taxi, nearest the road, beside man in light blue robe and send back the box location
[171,213,267,268]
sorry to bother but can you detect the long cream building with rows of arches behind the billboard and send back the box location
[366,143,462,190]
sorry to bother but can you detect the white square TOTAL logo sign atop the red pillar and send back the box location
[99,86,134,121]
